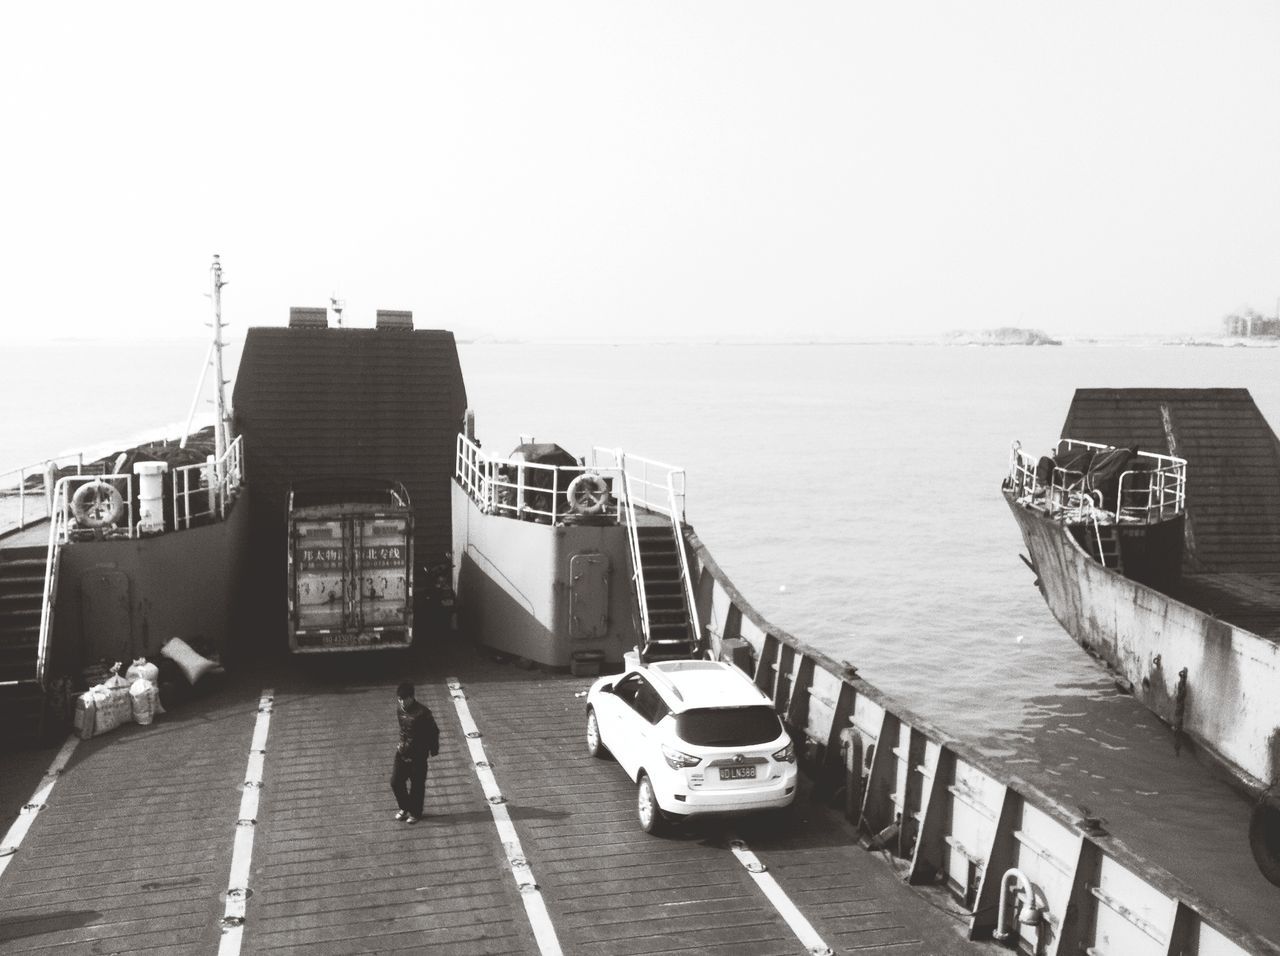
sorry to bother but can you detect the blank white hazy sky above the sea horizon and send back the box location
[0,0,1280,340]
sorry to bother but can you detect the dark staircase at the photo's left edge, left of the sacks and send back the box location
[0,545,47,741]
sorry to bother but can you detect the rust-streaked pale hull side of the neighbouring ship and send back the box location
[1010,493,1280,791]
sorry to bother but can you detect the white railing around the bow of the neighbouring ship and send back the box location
[1007,439,1187,523]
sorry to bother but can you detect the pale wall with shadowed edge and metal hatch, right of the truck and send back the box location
[453,482,637,668]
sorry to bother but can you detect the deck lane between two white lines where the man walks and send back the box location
[243,673,532,956]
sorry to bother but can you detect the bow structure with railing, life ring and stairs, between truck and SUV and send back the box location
[453,432,704,674]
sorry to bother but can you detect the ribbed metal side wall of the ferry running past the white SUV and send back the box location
[685,527,1277,956]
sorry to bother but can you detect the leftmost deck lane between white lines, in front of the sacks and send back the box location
[0,685,255,955]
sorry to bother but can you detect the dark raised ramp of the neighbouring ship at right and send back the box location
[1062,388,1280,573]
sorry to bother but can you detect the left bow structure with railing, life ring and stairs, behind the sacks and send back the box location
[0,429,248,738]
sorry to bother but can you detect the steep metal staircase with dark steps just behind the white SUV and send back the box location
[636,521,699,662]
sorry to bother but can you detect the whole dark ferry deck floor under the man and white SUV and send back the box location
[0,634,996,956]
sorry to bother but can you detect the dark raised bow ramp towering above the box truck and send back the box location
[233,328,466,563]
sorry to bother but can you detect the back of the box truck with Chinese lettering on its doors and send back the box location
[294,516,410,646]
